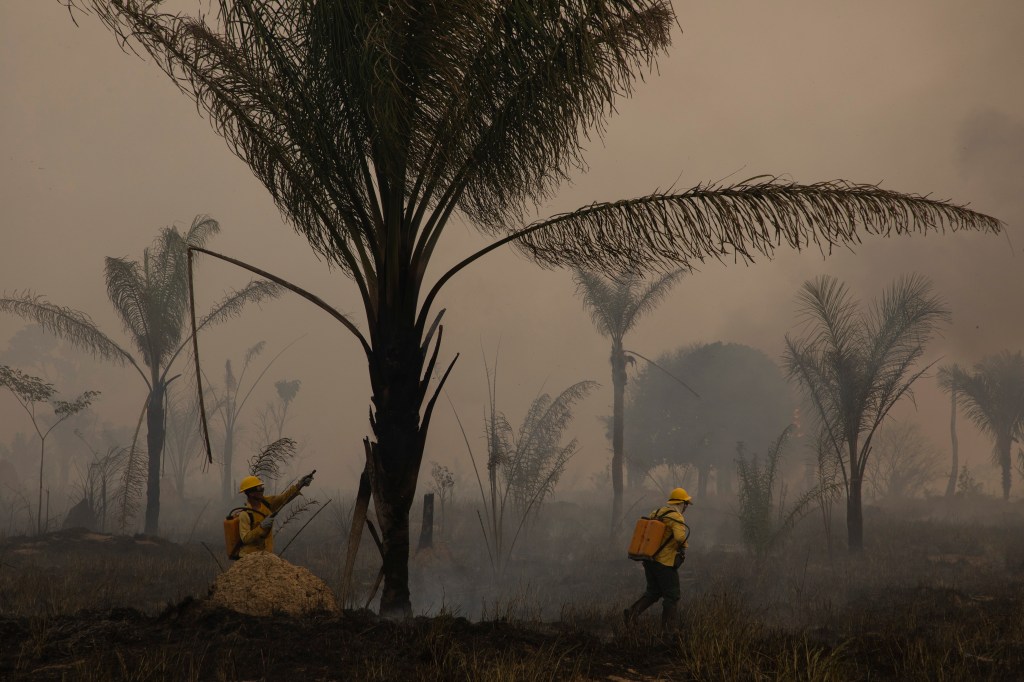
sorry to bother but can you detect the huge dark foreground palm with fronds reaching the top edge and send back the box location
[65,0,999,614]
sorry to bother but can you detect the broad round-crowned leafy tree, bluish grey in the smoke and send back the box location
[626,342,795,497]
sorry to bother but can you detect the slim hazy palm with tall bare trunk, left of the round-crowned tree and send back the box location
[573,269,686,536]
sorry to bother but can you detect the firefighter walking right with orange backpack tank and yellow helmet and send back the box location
[623,487,693,632]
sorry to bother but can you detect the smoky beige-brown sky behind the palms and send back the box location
[0,0,1024,495]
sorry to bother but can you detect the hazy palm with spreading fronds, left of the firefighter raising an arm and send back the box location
[0,216,280,535]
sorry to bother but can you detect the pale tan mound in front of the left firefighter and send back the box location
[209,552,338,615]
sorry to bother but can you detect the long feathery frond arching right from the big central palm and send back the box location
[516,178,1000,271]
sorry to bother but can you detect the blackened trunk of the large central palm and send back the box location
[370,306,429,617]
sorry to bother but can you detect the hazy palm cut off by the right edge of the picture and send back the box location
[944,350,1024,500]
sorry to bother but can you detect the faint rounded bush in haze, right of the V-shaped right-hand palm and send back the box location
[864,420,937,500]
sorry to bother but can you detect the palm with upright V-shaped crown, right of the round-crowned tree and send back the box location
[784,275,950,552]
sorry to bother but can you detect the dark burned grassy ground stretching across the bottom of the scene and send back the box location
[0,507,1024,680]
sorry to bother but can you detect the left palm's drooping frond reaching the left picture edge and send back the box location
[0,292,145,379]
